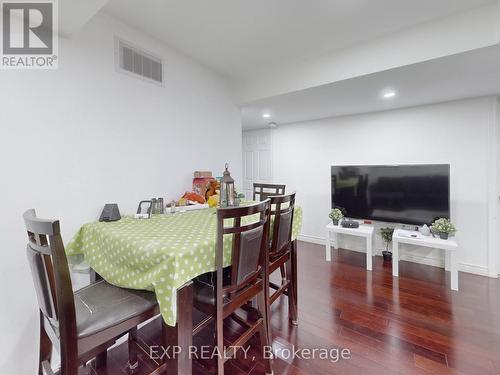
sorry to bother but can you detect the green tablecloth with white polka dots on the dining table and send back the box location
[66,206,302,326]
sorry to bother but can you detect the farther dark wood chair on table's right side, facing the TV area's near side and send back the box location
[267,193,298,325]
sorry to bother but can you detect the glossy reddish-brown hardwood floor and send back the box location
[76,242,500,375]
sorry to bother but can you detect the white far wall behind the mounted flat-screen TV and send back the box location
[258,98,498,275]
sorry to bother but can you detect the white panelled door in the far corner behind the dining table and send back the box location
[242,129,273,199]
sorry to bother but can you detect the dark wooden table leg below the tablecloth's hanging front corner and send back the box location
[163,281,193,375]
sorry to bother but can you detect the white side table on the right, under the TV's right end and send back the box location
[392,229,458,290]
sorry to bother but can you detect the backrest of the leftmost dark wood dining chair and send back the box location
[23,209,76,342]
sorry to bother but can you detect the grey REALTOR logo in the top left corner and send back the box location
[1,0,58,69]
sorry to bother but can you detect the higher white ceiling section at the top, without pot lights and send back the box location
[104,0,493,80]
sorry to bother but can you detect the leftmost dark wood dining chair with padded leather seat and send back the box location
[24,210,159,375]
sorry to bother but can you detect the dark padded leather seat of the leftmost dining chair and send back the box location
[75,280,157,338]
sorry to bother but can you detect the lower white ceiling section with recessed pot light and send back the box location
[242,46,500,129]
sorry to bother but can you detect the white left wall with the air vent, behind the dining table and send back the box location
[0,14,241,374]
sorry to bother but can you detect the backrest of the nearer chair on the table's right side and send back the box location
[216,200,270,293]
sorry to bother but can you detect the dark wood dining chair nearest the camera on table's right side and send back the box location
[193,200,272,375]
